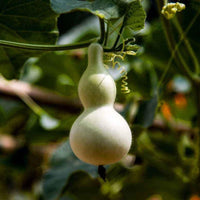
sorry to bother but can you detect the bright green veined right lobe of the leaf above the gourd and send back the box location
[124,0,146,31]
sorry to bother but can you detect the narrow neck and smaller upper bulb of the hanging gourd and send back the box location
[78,43,116,109]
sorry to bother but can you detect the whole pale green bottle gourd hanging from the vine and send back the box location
[69,43,132,165]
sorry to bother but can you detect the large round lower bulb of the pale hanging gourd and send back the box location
[70,106,132,165]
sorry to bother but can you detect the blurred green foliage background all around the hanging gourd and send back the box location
[0,0,200,200]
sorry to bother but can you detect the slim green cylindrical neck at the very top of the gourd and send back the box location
[88,43,103,67]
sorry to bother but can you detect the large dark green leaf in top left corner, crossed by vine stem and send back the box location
[0,0,57,78]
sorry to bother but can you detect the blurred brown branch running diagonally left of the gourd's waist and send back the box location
[0,78,82,113]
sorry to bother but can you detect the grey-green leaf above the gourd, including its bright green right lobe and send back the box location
[51,0,146,33]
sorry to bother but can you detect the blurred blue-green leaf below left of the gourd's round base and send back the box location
[43,142,97,200]
